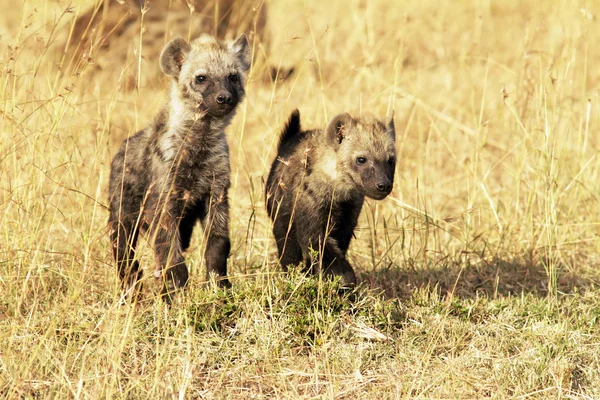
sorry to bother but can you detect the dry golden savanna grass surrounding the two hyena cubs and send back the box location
[0,0,600,399]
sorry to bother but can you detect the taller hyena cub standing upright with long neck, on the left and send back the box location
[109,35,250,301]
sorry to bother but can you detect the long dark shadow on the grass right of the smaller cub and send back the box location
[361,259,600,299]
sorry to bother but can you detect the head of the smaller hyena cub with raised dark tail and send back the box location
[325,113,396,200]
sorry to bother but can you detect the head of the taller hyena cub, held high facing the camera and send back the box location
[160,34,251,117]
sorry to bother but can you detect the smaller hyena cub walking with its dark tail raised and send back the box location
[266,110,396,285]
